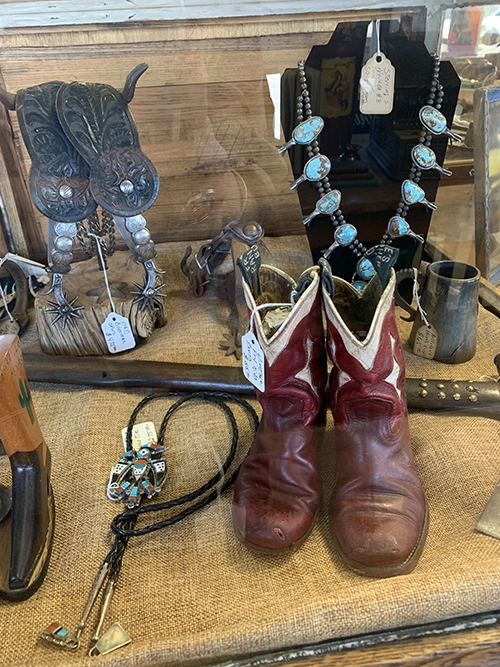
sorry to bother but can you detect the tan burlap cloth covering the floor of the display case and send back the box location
[0,238,500,667]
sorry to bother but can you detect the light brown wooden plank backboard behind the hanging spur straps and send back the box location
[0,12,398,260]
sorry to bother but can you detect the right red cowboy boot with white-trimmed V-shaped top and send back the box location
[323,264,428,577]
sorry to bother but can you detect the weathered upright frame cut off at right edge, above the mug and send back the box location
[474,86,500,285]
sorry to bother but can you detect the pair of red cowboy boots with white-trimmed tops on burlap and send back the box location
[232,250,428,577]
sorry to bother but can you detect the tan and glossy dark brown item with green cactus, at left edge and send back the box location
[0,336,55,600]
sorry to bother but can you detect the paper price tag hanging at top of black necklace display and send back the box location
[359,21,395,115]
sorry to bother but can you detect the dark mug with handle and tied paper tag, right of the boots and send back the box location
[396,261,481,364]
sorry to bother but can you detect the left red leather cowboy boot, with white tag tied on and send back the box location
[232,253,326,552]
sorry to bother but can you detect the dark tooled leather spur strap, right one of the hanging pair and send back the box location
[56,82,159,217]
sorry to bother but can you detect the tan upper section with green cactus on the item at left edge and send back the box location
[0,335,46,458]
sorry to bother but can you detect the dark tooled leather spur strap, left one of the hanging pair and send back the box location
[16,81,97,222]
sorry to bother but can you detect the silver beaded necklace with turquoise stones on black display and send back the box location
[290,54,460,280]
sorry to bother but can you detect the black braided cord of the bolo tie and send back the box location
[104,392,259,582]
